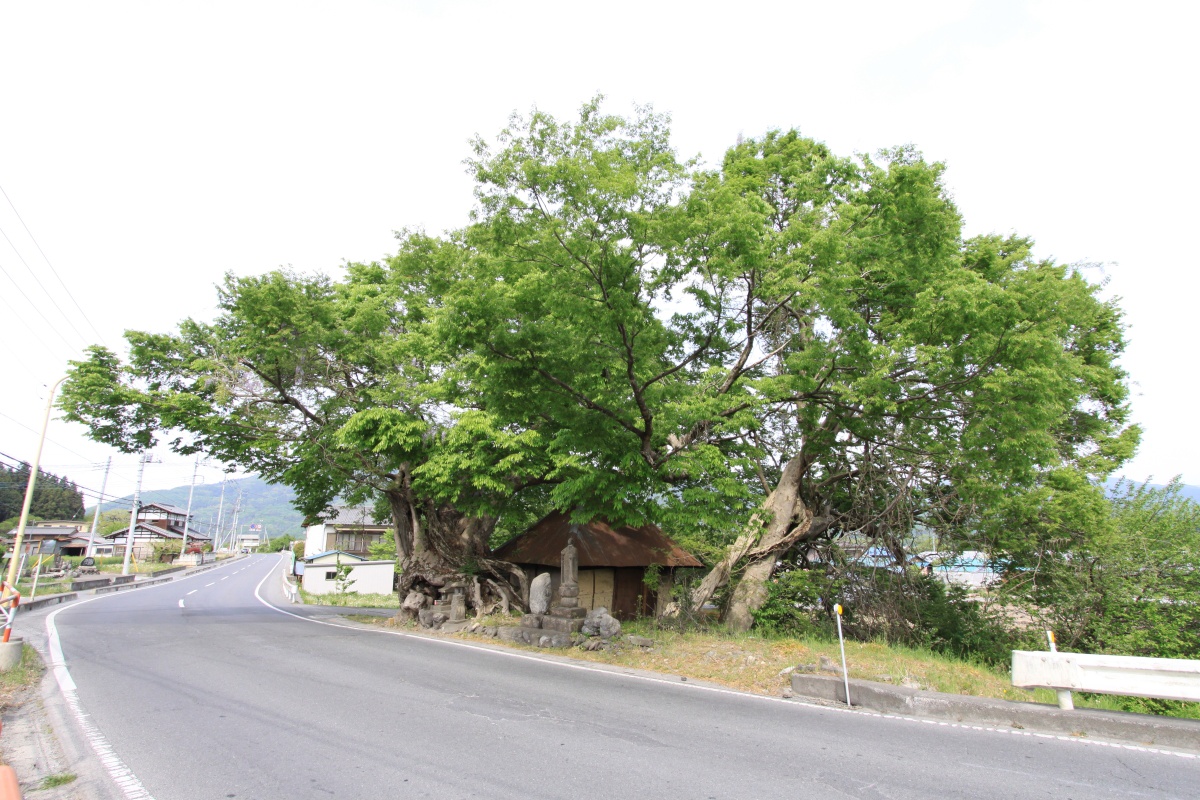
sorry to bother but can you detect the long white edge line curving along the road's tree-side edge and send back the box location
[254,560,1200,759]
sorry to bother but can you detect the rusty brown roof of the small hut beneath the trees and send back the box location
[494,511,704,567]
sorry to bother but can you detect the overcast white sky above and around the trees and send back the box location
[0,0,1200,506]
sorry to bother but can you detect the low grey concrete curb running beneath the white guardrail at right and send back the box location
[792,673,1200,751]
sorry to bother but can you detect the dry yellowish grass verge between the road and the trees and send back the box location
[360,614,1200,718]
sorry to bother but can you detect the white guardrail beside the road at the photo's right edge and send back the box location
[1013,650,1200,708]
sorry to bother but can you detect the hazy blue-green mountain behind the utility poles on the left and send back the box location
[88,476,304,539]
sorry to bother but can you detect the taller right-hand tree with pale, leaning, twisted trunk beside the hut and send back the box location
[446,103,1138,628]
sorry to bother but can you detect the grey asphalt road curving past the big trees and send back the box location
[18,555,1200,800]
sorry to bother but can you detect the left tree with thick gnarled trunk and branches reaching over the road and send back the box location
[60,234,546,610]
